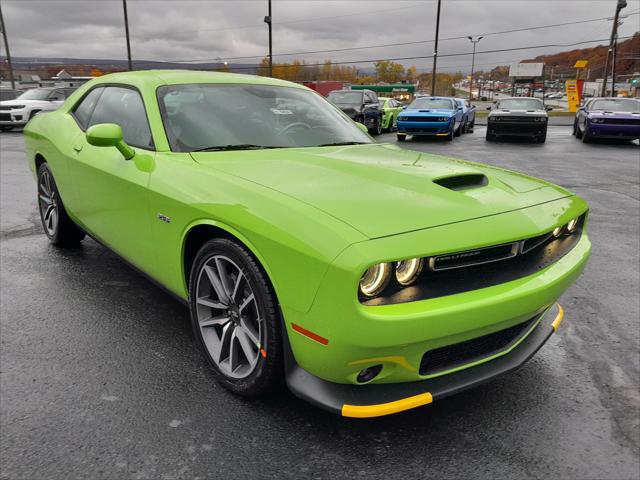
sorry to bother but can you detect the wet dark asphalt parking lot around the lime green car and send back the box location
[0,127,640,480]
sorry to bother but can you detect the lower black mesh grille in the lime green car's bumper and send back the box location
[420,316,538,375]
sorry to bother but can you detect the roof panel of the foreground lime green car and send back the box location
[84,70,307,89]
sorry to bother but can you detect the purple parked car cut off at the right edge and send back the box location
[573,97,640,143]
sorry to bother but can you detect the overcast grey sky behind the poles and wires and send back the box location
[0,0,640,71]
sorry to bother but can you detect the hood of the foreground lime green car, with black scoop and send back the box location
[192,144,571,238]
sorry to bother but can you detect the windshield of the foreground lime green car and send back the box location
[158,84,372,152]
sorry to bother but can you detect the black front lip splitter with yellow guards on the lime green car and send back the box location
[285,304,564,418]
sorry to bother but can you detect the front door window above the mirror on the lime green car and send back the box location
[89,87,153,148]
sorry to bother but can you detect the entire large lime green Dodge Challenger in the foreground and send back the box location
[25,71,591,417]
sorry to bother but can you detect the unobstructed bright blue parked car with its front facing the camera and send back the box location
[398,97,463,142]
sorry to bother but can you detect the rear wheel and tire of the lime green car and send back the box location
[38,162,86,246]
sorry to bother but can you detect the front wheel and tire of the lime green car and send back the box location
[189,238,284,397]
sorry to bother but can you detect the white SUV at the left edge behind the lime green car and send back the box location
[0,88,75,131]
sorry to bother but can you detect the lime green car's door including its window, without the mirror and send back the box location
[70,86,155,270]
